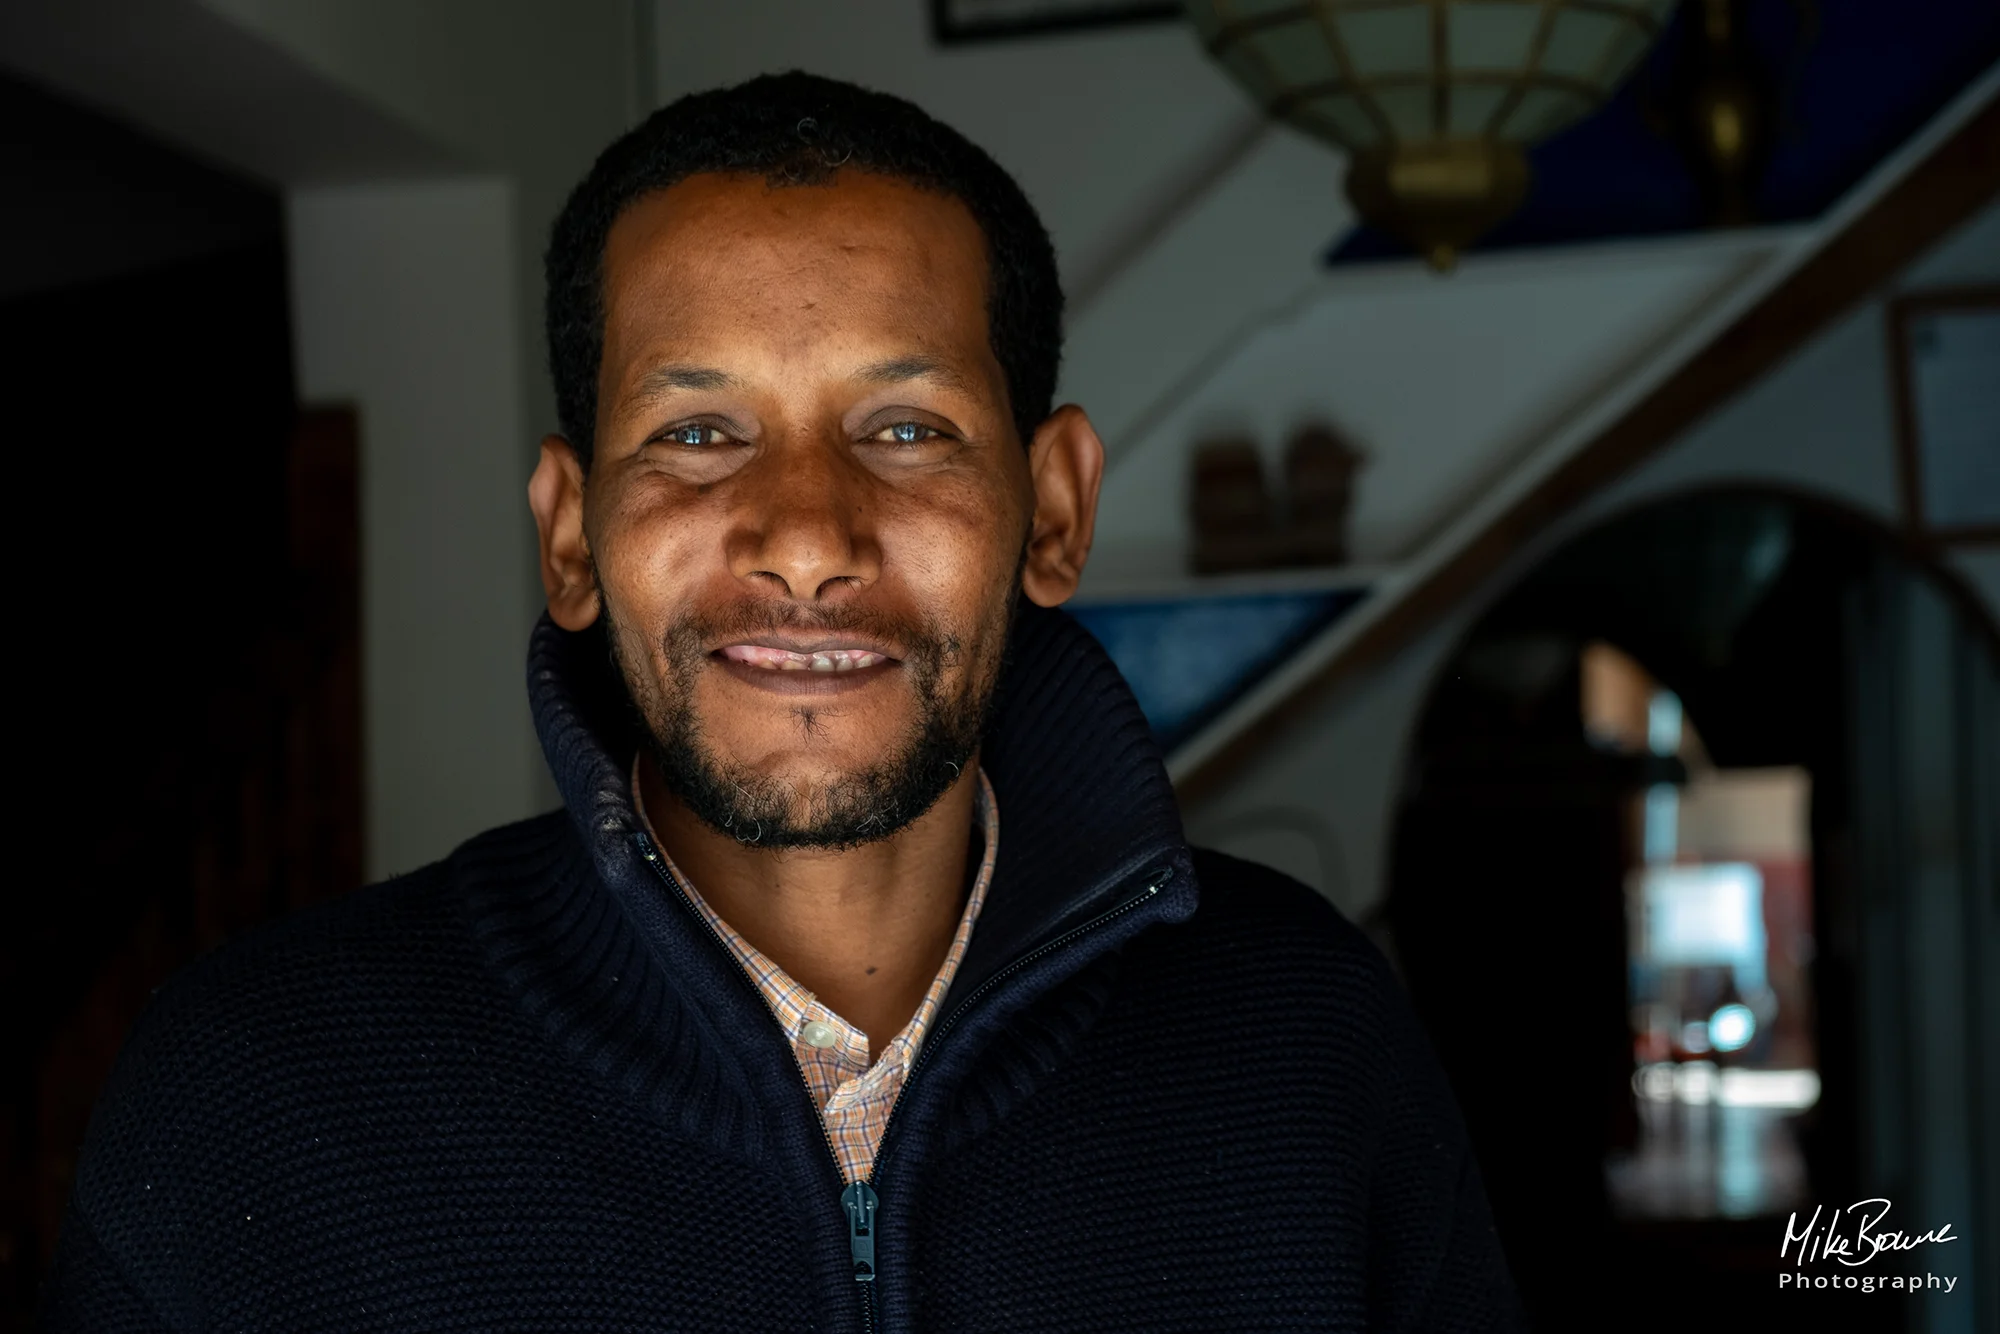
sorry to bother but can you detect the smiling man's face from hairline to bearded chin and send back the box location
[536,172,1094,846]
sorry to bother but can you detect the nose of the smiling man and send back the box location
[728,432,882,602]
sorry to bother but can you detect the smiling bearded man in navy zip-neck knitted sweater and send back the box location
[46,74,1514,1332]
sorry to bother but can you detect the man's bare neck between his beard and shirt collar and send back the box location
[640,756,980,1054]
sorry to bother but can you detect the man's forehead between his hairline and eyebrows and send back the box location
[604,170,988,374]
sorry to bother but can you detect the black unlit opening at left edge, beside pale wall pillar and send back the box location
[0,75,362,1328]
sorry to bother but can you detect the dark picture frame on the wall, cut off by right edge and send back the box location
[1888,284,2000,546]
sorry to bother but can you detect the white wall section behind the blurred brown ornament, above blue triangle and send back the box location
[1098,236,1776,568]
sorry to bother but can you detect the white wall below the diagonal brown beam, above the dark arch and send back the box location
[1186,204,2000,918]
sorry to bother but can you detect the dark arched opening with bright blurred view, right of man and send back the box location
[1386,490,2000,1330]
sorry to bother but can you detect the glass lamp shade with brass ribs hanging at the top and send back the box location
[1188,0,1674,268]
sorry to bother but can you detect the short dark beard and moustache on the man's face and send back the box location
[600,572,1026,850]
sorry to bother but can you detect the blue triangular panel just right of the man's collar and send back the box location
[1070,588,1366,750]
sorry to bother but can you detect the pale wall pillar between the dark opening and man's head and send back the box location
[286,178,542,878]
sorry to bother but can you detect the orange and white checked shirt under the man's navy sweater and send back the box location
[632,756,1000,1182]
